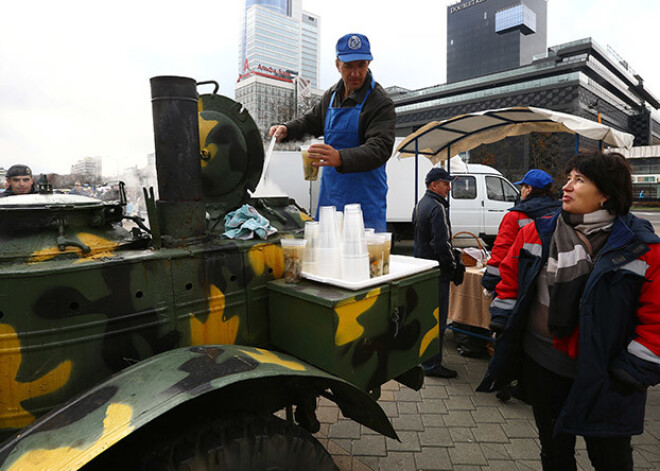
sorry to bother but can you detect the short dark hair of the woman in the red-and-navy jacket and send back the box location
[566,152,632,216]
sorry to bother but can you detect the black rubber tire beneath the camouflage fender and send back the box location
[90,415,338,471]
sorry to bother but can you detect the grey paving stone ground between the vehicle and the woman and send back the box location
[316,331,660,471]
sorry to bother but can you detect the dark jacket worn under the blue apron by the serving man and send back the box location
[283,71,396,173]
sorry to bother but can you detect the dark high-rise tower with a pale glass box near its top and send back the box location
[447,0,548,83]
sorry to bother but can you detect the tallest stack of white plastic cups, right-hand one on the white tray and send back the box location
[342,204,369,281]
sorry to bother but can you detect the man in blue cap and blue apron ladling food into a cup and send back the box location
[270,33,396,232]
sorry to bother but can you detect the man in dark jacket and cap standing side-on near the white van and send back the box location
[413,167,462,378]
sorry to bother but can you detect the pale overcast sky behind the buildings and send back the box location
[0,0,660,175]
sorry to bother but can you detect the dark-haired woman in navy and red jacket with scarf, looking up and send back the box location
[477,152,660,471]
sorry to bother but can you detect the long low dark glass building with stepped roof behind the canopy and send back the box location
[391,37,660,181]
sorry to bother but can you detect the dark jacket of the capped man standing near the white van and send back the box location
[413,190,456,280]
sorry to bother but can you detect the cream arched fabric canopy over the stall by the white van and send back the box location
[396,106,633,165]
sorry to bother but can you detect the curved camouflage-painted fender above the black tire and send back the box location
[0,345,397,471]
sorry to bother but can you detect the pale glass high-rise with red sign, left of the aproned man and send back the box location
[235,0,320,138]
